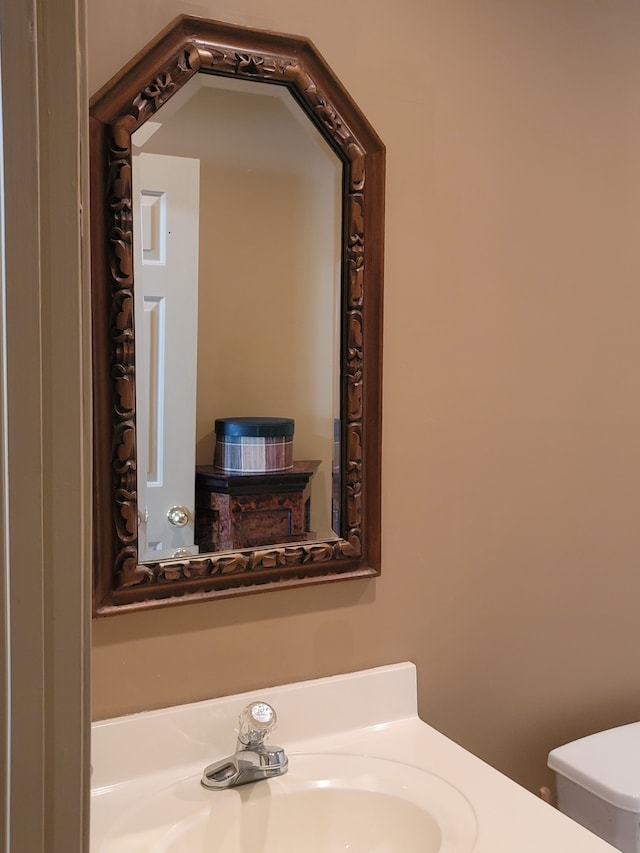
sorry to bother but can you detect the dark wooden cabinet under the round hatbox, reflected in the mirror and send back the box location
[195,460,320,553]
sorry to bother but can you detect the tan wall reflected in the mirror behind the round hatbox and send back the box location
[196,163,339,536]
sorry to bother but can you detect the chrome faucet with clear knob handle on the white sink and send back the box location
[201,702,288,790]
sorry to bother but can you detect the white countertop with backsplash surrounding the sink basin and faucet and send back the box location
[90,663,614,853]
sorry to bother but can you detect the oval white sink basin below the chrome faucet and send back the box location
[92,753,476,853]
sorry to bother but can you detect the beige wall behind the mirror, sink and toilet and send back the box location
[89,0,640,789]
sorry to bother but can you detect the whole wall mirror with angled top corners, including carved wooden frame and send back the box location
[90,16,384,615]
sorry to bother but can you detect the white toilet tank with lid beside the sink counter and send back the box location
[548,723,640,853]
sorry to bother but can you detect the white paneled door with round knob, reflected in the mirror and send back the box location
[133,154,200,560]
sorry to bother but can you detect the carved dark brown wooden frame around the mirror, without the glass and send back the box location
[90,16,385,616]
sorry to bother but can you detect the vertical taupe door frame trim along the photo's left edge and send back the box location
[0,0,91,853]
